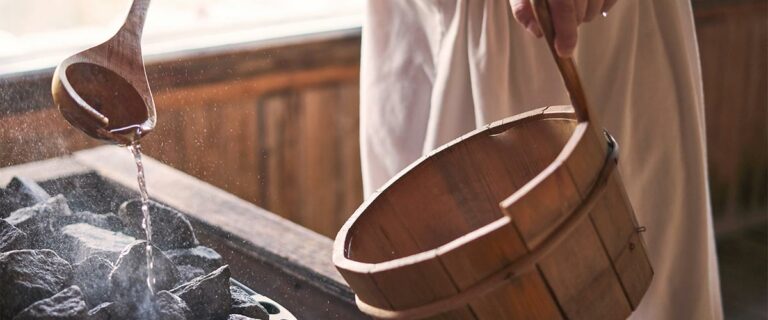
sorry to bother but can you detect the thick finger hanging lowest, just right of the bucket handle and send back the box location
[549,0,578,57]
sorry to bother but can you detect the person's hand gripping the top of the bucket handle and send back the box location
[509,0,617,57]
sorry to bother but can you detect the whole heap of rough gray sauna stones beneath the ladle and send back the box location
[0,179,284,320]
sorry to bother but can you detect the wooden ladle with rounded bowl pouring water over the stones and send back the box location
[51,0,157,145]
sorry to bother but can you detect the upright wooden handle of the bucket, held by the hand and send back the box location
[531,0,592,122]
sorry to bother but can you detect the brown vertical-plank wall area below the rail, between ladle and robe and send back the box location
[144,79,362,236]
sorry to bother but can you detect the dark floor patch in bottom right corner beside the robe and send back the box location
[717,223,768,319]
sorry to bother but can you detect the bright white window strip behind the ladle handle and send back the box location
[0,0,364,74]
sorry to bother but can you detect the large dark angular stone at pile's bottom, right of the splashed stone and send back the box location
[171,266,230,320]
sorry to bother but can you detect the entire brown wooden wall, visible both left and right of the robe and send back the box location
[0,0,768,237]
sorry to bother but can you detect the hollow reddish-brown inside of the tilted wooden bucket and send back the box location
[344,114,577,263]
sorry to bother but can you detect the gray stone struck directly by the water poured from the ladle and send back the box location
[109,241,179,305]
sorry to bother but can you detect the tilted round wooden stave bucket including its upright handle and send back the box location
[333,0,653,319]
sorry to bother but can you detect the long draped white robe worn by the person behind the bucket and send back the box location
[360,0,722,320]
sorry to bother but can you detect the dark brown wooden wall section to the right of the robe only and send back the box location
[694,0,768,232]
